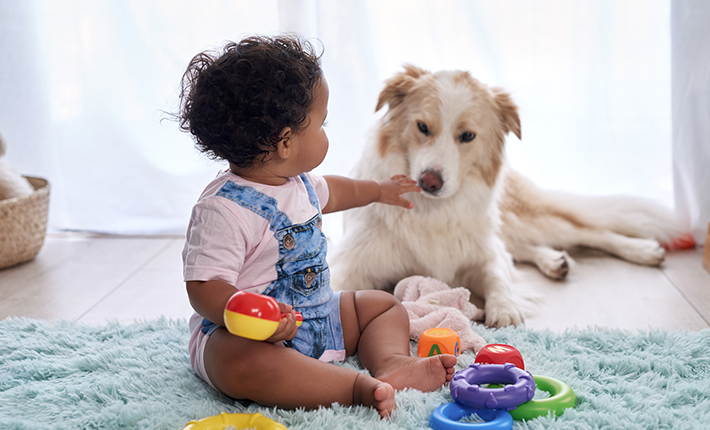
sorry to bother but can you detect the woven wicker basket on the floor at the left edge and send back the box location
[0,176,49,269]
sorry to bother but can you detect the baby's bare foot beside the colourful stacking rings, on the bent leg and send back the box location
[375,354,456,393]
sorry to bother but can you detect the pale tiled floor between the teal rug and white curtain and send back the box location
[0,234,710,331]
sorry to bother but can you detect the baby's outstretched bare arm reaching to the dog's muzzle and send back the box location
[323,175,422,213]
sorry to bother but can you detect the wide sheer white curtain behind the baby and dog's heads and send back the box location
[0,0,696,242]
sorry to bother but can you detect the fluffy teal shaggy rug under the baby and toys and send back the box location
[0,319,710,430]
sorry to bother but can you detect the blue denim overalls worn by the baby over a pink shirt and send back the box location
[202,174,345,358]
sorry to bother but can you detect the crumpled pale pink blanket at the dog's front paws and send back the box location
[394,276,486,352]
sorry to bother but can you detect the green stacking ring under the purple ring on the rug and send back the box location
[510,375,577,421]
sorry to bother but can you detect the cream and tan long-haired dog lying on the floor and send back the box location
[329,65,681,327]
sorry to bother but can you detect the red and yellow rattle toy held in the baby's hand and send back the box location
[224,291,303,340]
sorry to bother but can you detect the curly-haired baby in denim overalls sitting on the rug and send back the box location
[178,36,456,417]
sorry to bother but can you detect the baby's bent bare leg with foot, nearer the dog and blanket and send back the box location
[340,290,456,392]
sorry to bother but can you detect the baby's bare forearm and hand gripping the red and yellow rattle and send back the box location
[187,280,298,343]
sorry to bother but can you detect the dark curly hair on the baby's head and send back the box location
[177,35,323,167]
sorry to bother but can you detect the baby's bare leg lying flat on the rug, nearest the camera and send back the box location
[205,328,394,417]
